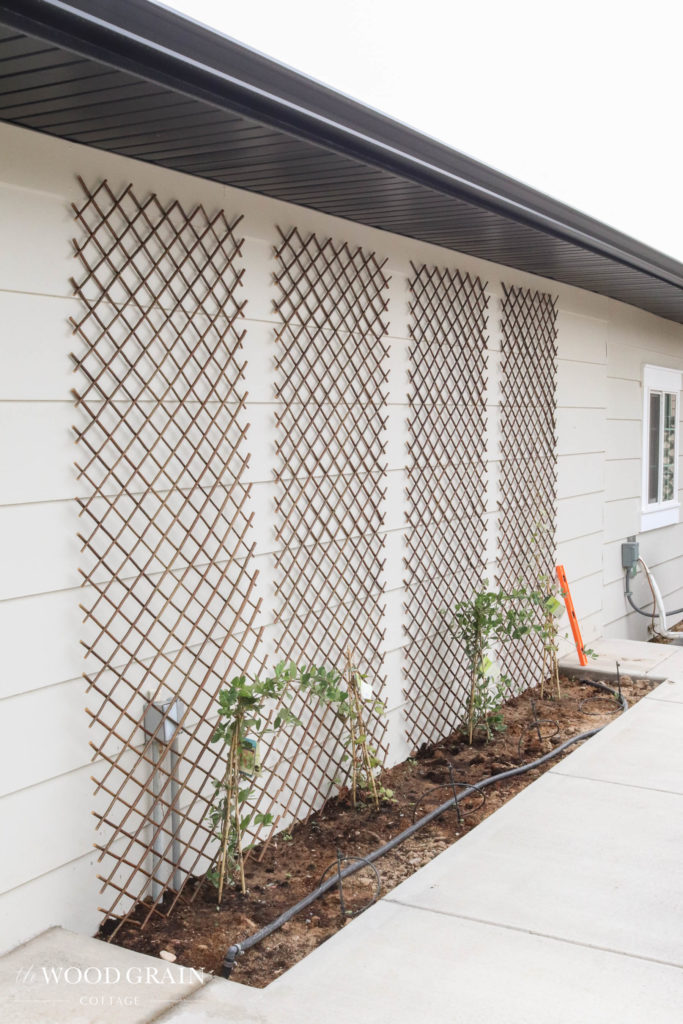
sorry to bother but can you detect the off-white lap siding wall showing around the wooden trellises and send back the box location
[0,119,683,950]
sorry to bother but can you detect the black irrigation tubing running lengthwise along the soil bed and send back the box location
[220,678,629,978]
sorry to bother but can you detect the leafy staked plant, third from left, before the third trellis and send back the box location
[441,581,537,743]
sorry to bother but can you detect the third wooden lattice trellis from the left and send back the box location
[404,265,488,748]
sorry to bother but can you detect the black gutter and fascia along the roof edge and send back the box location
[0,0,683,299]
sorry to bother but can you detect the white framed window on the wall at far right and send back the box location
[640,366,682,530]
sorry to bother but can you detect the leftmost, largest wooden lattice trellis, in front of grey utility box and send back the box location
[72,181,261,933]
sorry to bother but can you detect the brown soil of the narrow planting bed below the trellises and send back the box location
[101,676,655,987]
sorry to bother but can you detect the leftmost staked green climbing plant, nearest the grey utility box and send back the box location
[209,662,339,903]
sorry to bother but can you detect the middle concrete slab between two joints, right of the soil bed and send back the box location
[387,772,683,967]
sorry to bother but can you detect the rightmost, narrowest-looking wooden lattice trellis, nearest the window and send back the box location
[498,285,557,692]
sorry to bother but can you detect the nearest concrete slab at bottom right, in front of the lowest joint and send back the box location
[160,901,681,1024]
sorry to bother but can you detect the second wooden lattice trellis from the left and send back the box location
[265,228,388,819]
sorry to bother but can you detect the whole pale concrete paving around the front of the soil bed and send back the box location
[0,675,683,1024]
